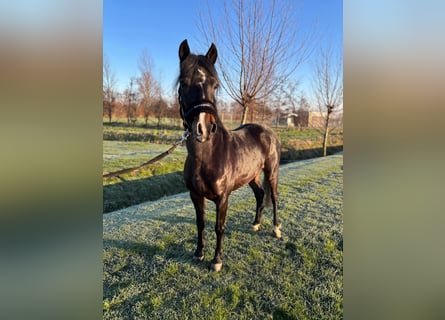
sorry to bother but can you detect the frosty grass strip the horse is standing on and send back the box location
[103,155,343,319]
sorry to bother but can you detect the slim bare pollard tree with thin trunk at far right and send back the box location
[312,47,343,156]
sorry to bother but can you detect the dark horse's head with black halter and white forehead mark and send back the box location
[178,40,220,142]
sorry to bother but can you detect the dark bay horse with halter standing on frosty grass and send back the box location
[178,40,281,271]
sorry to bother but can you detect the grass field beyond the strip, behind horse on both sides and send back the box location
[103,119,343,213]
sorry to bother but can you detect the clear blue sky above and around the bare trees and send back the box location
[103,0,343,101]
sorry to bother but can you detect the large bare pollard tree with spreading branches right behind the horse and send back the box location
[200,0,309,124]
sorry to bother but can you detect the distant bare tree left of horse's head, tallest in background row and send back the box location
[136,49,161,126]
